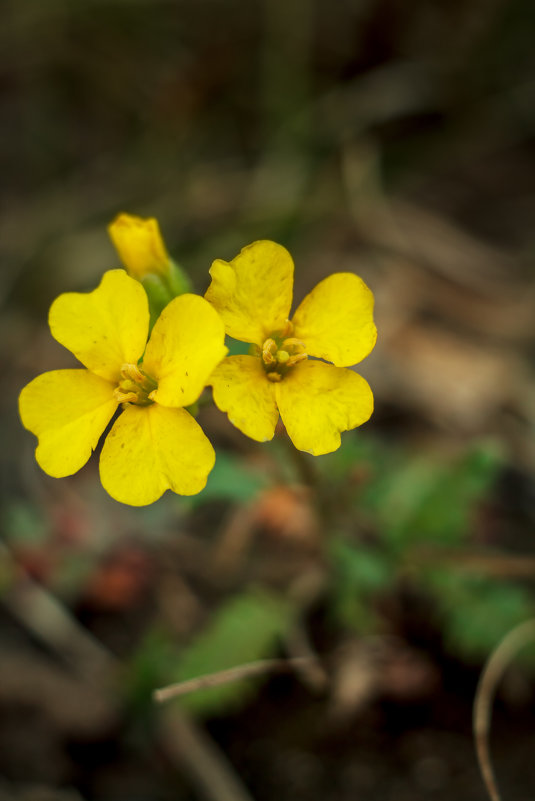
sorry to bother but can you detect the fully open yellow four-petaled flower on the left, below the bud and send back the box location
[19,270,227,506]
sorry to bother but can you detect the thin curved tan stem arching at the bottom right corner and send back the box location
[473,619,535,801]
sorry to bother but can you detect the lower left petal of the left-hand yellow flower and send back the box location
[19,369,118,478]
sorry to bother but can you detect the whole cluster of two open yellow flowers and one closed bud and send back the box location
[19,214,376,506]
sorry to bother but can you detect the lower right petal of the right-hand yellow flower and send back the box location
[275,360,373,456]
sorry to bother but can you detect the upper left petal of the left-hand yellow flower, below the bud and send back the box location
[48,270,149,381]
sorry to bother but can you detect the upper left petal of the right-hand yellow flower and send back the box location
[205,240,294,345]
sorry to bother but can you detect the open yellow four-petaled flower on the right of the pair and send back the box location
[205,241,377,456]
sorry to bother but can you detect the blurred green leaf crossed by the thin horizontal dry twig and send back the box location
[174,592,293,715]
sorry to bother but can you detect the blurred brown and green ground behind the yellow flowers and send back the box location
[0,0,535,801]
